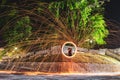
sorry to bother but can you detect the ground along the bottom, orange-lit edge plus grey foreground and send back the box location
[0,71,120,80]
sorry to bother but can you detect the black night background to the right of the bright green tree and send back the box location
[104,0,120,48]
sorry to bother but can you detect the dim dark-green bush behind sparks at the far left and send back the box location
[4,16,32,44]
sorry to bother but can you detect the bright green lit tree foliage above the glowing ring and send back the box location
[49,0,108,46]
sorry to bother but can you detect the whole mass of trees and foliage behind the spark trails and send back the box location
[0,0,108,58]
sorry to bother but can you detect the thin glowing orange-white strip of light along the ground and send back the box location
[0,71,120,76]
